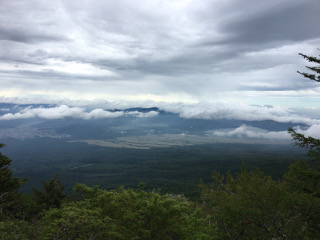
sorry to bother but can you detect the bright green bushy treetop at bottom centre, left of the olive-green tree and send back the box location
[38,184,214,240]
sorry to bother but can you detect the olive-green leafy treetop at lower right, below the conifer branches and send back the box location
[201,168,320,239]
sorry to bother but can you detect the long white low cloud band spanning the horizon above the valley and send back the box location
[0,101,320,126]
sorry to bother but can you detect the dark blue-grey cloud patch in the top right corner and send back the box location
[220,1,320,46]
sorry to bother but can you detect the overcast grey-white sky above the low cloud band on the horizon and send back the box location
[0,0,320,108]
